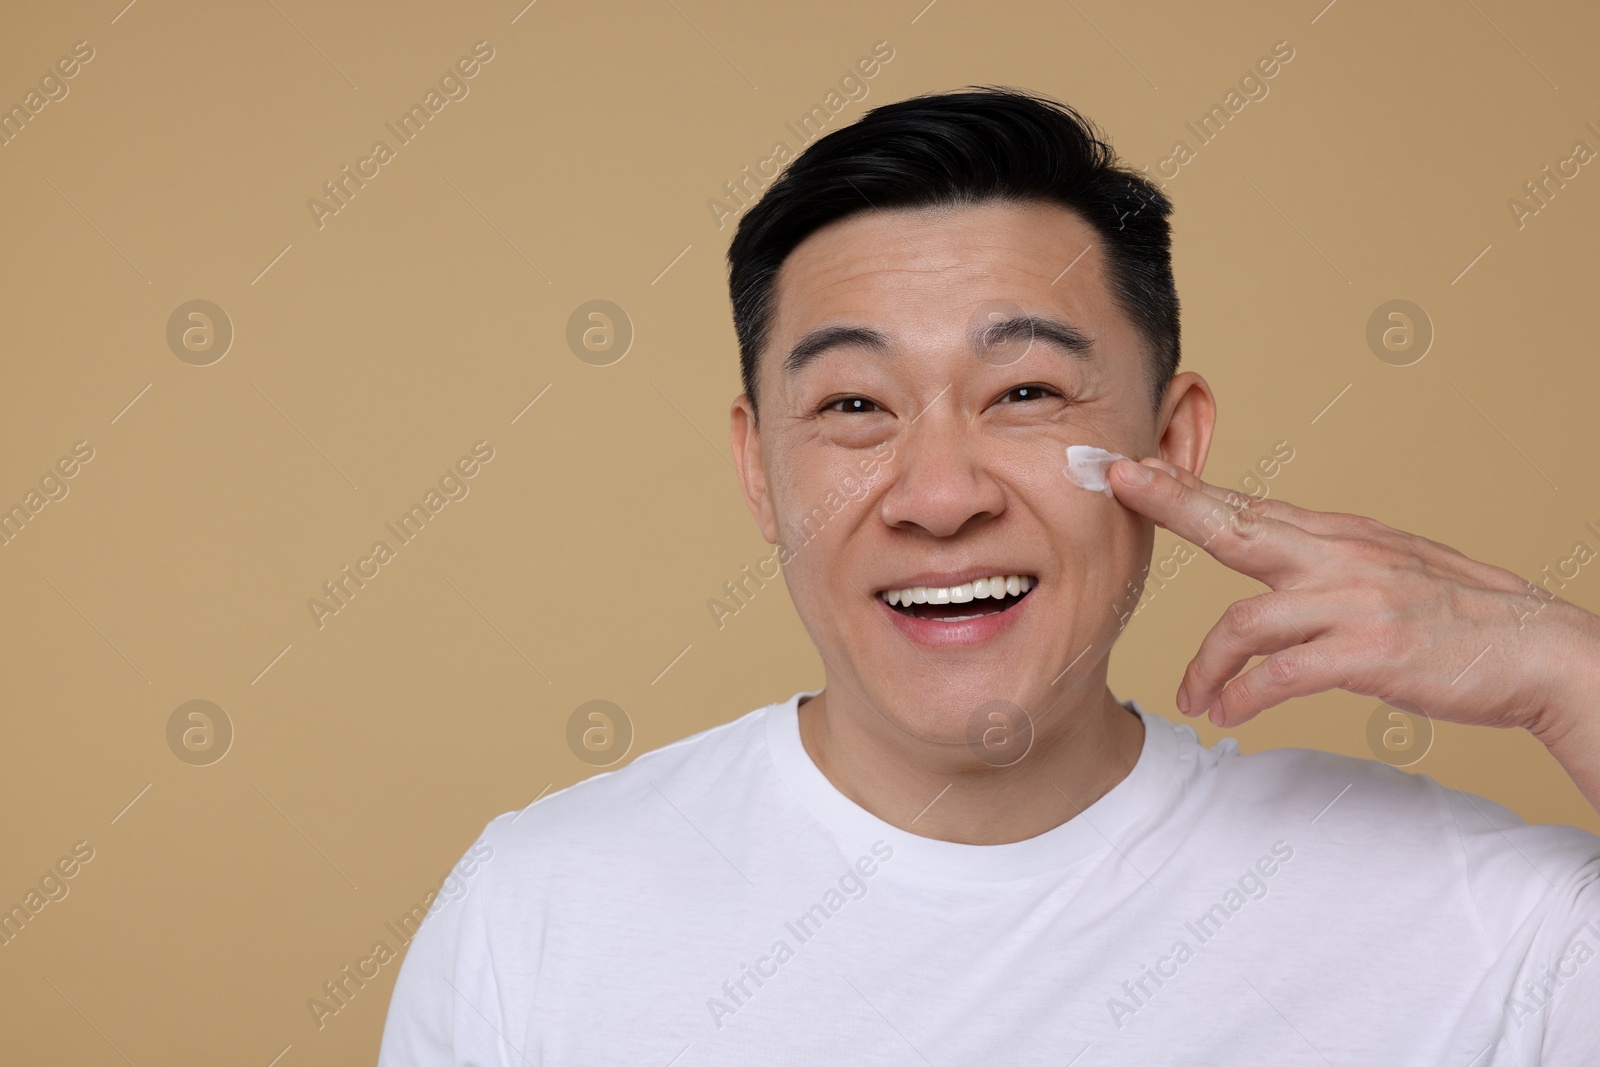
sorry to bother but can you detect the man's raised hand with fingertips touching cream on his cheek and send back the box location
[1110,459,1600,751]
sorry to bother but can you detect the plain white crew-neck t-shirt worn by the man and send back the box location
[379,691,1600,1067]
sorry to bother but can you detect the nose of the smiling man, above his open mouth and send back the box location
[878,395,1005,537]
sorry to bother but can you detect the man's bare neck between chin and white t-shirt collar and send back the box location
[800,675,1144,845]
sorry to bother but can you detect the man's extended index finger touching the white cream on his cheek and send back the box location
[1109,459,1318,589]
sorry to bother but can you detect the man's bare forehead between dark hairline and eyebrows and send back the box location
[768,202,1131,350]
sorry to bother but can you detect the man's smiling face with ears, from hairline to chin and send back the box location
[733,202,1211,755]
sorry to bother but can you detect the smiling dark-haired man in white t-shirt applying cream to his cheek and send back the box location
[379,90,1600,1067]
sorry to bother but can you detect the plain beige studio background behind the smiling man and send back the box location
[0,0,1600,1067]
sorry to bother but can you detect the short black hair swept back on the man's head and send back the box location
[728,85,1179,422]
